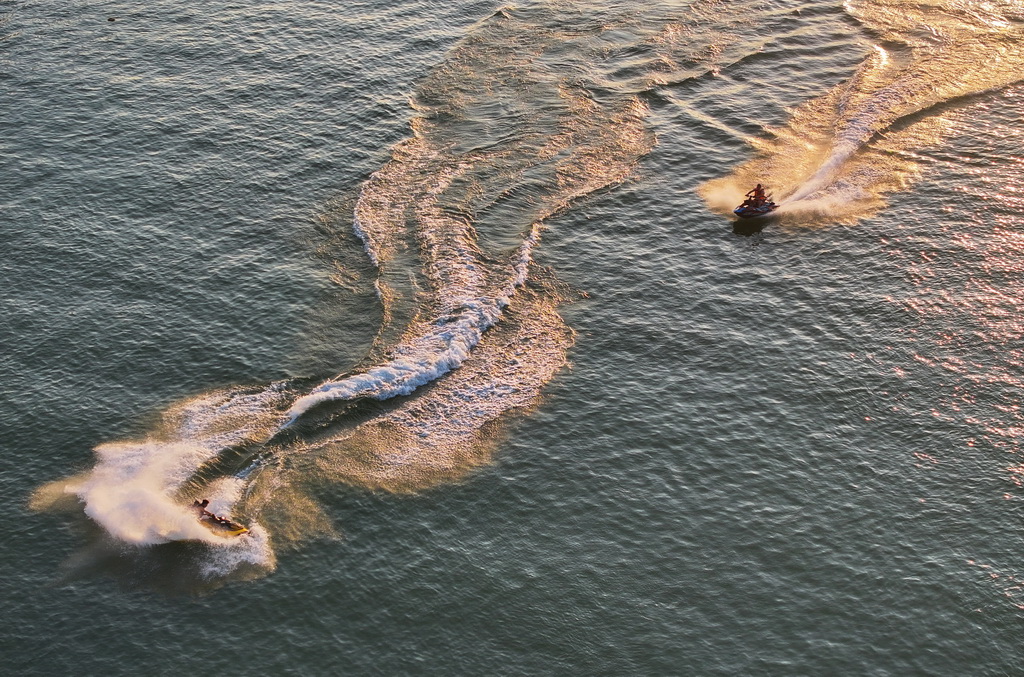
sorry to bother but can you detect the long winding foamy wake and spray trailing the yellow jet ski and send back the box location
[36,0,806,580]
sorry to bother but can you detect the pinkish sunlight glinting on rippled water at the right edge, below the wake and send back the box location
[883,86,1024,499]
